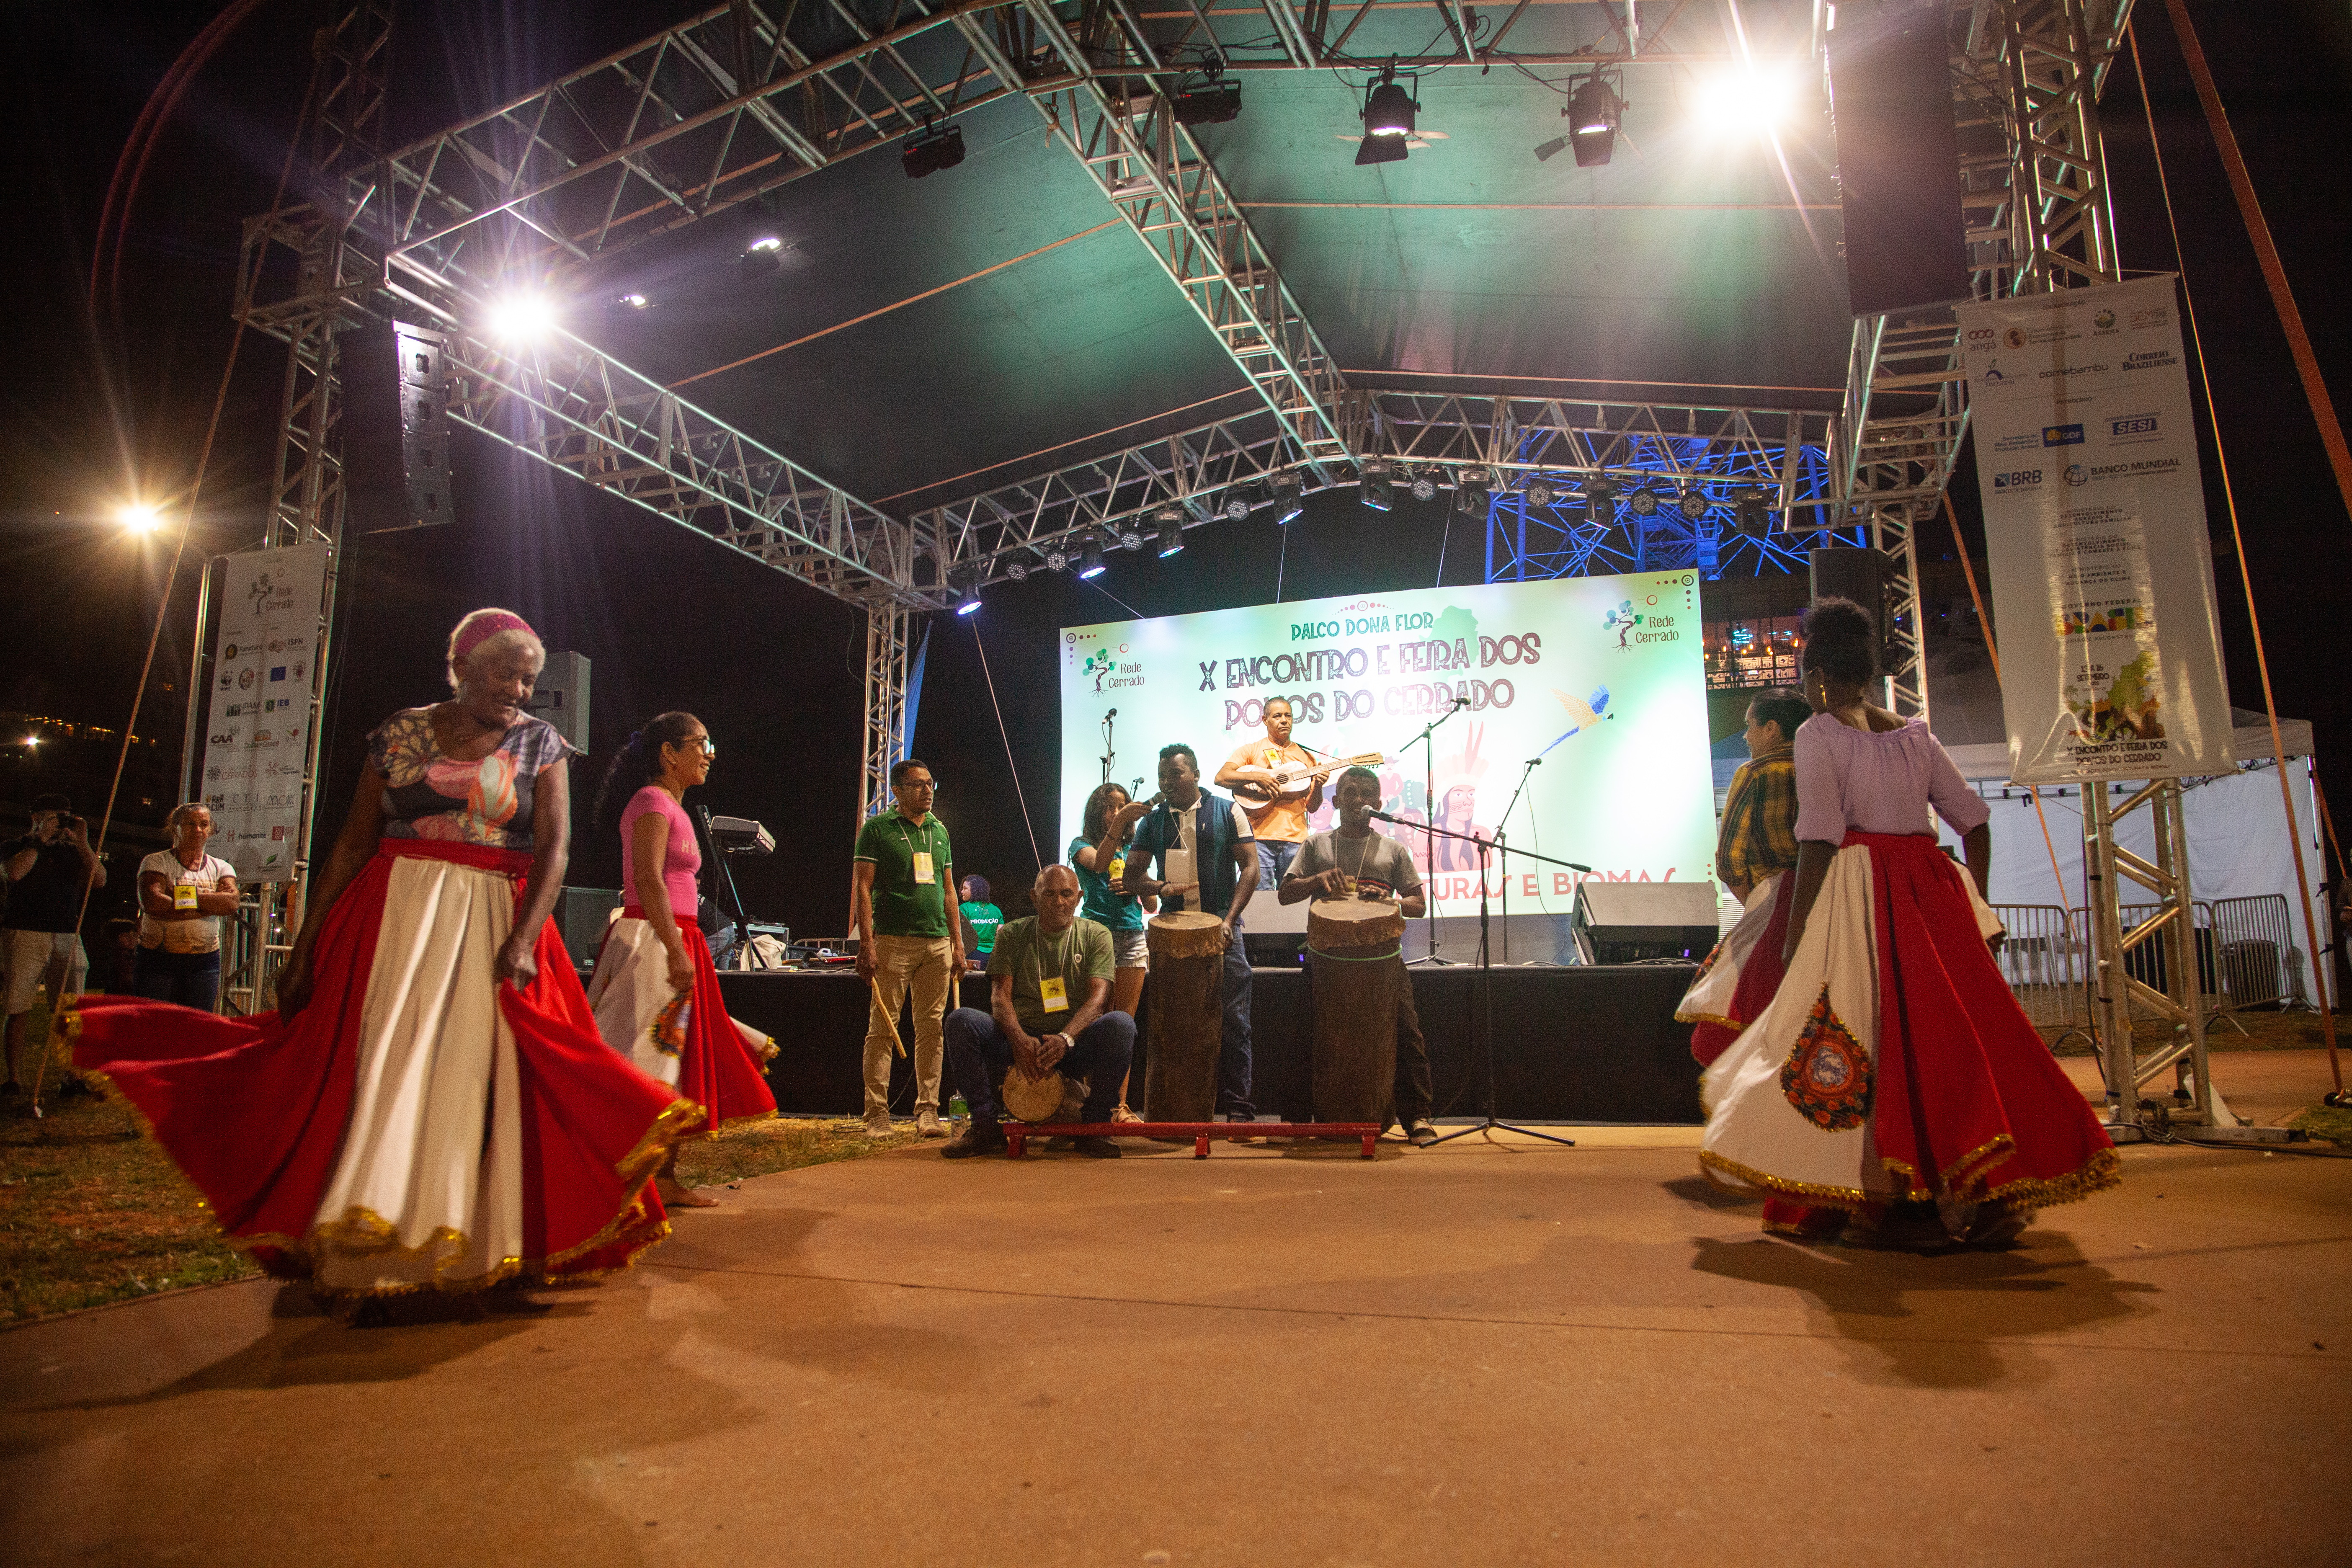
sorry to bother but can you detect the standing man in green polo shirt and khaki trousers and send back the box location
[849,757,965,1138]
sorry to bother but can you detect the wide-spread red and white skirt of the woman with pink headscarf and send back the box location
[68,839,703,1295]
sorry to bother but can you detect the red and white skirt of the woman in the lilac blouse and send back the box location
[1698,832,2119,1218]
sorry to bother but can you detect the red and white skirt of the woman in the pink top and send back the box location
[588,905,776,1138]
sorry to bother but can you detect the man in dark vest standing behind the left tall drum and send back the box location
[1119,743,1259,1121]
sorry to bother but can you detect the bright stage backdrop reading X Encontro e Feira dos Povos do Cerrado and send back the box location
[1054,571,1715,907]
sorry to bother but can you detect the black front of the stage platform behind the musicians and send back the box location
[720,964,1703,1124]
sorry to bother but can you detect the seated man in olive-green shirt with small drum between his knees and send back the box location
[941,865,1136,1159]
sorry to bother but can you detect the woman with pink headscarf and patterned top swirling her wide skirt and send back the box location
[70,609,703,1305]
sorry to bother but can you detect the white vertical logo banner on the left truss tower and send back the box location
[200,545,327,886]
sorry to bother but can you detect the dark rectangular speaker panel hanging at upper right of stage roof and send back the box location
[1830,0,1969,315]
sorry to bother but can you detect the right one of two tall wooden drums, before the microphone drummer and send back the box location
[1308,898,1409,1126]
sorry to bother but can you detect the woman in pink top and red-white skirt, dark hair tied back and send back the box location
[588,712,776,1208]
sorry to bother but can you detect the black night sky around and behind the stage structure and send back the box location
[0,0,2352,933]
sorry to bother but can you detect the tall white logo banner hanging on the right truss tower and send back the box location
[1959,275,2232,783]
